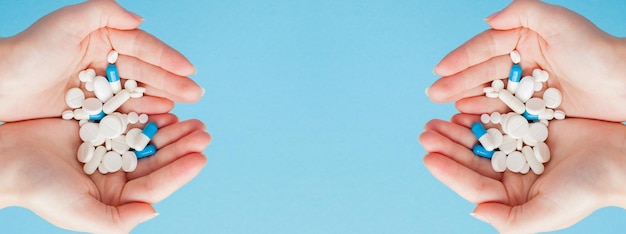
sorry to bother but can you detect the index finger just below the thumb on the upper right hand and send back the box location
[434,30,520,76]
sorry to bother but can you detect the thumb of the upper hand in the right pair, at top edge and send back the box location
[486,0,599,38]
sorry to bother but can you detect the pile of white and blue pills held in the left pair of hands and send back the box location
[61,51,158,175]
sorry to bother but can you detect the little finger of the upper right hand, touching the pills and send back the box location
[455,96,510,114]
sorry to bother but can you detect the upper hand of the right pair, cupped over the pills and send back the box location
[427,0,626,122]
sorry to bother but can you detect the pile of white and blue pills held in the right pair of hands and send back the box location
[471,51,565,175]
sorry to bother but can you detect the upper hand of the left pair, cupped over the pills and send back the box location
[0,0,203,122]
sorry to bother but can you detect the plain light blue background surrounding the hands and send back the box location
[0,0,626,233]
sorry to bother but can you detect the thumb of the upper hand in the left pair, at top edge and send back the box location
[41,0,143,41]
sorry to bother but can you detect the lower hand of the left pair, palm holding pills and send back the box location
[0,114,210,233]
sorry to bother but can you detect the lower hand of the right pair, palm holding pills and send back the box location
[420,114,626,233]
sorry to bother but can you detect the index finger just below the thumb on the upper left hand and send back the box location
[109,30,196,76]
